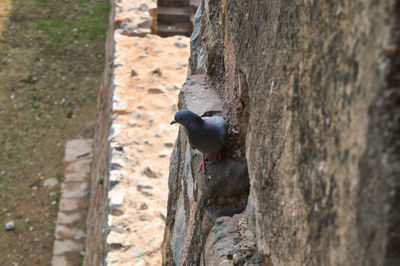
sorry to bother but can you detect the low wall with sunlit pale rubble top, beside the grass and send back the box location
[83,0,180,266]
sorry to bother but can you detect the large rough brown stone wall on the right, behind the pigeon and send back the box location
[163,0,400,265]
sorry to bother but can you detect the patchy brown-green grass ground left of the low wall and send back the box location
[0,0,109,265]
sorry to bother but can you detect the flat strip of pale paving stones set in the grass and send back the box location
[53,140,92,265]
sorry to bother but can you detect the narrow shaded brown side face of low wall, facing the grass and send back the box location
[83,1,115,265]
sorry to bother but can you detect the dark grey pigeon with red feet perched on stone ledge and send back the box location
[171,109,228,174]
